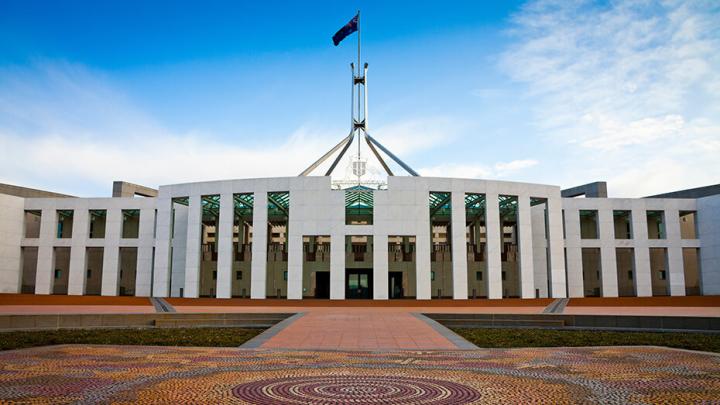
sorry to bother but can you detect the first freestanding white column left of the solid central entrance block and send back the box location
[250,191,267,298]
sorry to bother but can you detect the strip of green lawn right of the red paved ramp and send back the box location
[453,328,720,353]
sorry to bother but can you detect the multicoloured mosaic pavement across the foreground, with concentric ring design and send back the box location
[0,345,720,405]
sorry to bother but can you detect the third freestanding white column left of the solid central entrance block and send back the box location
[183,195,202,298]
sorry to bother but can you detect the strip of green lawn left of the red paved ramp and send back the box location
[0,328,263,350]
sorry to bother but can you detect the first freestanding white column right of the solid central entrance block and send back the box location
[450,190,468,300]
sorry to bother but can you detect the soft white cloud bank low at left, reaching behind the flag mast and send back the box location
[0,63,457,196]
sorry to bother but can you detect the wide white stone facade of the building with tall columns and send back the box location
[0,176,720,299]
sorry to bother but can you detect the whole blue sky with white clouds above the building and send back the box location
[0,0,720,196]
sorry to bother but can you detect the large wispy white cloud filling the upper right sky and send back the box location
[501,0,720,196]
